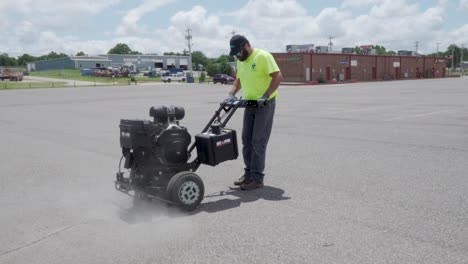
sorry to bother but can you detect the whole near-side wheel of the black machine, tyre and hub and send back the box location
[167,171,205,211]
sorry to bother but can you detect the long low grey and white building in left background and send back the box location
[27,54,192,71]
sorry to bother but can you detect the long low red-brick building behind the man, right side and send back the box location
[273,53,446,82]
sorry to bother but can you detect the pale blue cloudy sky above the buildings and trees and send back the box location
[0,0,468,57]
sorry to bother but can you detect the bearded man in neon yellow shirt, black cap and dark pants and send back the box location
[229,35,283,190]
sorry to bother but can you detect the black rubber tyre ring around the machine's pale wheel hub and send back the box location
[167,171,205,211]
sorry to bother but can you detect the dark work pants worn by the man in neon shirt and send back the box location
[242,99,276,181]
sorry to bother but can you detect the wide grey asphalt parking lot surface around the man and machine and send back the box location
[0,78,468,264]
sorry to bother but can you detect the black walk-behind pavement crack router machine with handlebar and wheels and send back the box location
[115,99,260,211]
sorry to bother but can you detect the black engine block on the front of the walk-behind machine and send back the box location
[119,106,191,186]
